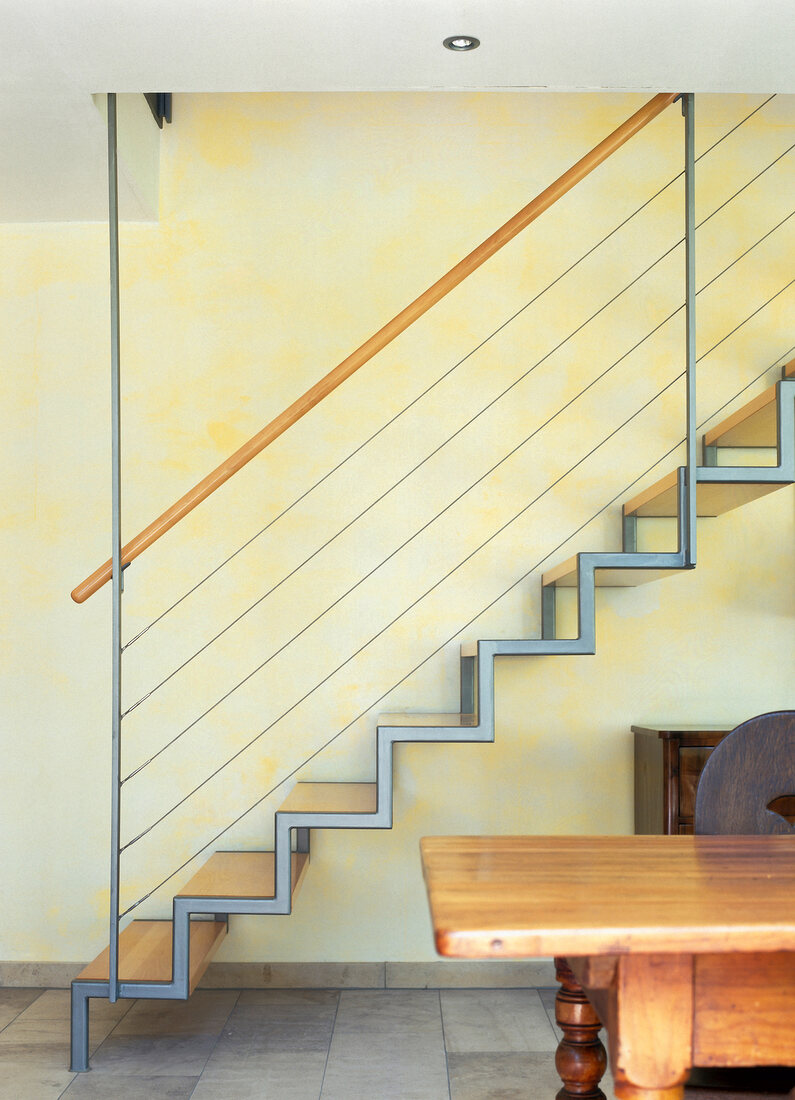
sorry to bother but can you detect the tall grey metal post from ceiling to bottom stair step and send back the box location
[108,92,122,1002]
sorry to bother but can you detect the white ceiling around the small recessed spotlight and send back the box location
[0,0,795,221]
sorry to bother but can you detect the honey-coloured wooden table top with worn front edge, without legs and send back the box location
[421,834,795,958]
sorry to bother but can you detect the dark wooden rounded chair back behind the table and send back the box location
[695,711,795,835]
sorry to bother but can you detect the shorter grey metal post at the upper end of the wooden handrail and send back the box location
[682,91,697,565]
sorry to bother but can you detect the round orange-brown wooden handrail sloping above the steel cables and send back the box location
[71,92,677,604]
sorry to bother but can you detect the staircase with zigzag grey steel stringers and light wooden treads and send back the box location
[71,360,795,1071]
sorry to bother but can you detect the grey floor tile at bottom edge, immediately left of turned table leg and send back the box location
[450,1053,561,1100]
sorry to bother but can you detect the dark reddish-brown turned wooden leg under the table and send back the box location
[555,958,607,1100]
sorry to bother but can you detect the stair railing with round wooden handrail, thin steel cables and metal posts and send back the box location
[85,96,794,999]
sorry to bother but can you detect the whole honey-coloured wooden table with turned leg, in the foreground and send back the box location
[421,835,795,1100]
